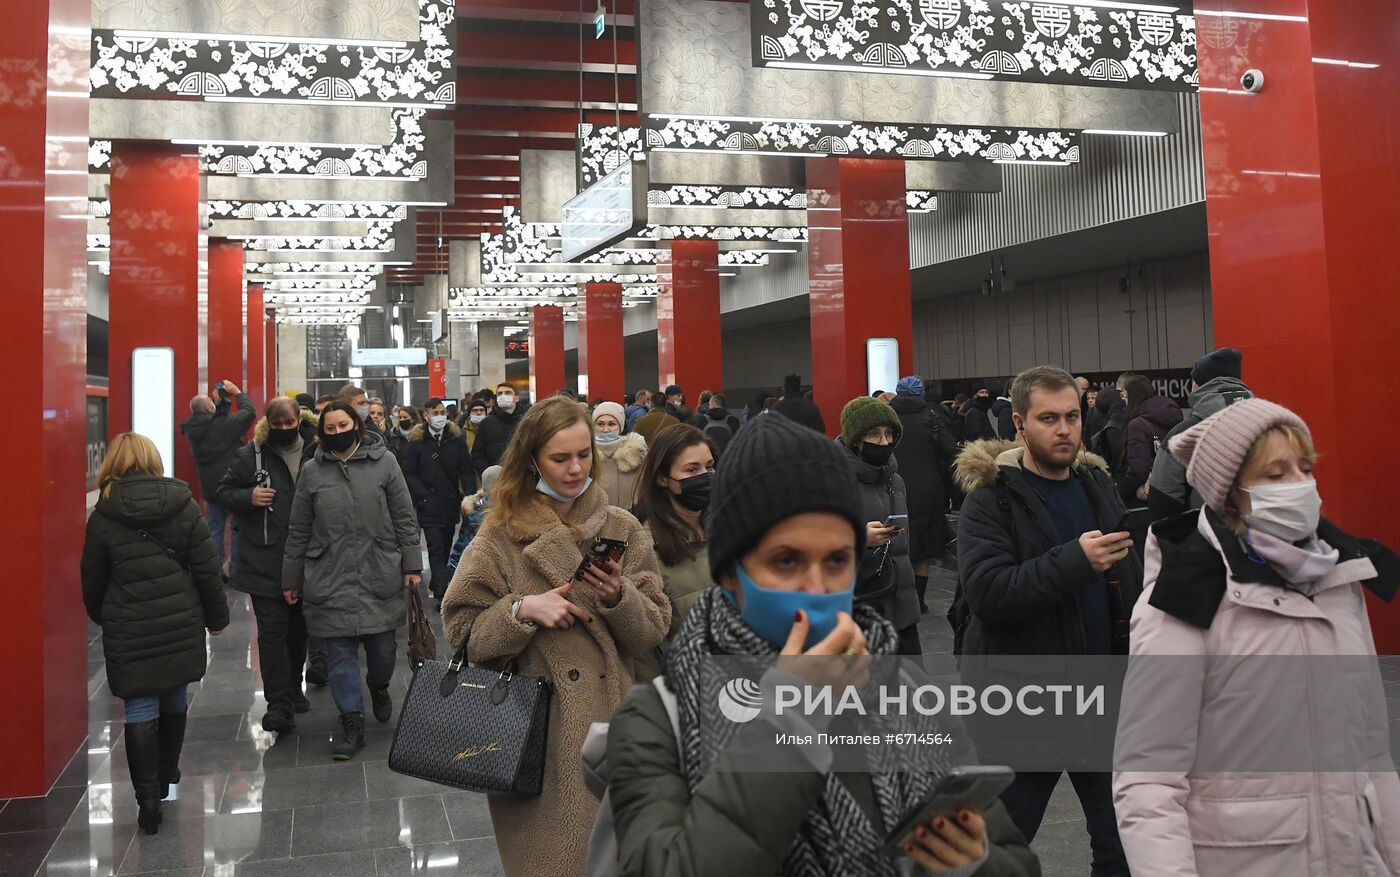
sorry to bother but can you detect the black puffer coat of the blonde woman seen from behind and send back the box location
[83,475,228,698]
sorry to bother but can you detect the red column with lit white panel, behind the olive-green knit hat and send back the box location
[806,158,914,434]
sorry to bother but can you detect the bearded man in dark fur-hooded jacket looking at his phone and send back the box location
[958,367,1142,877]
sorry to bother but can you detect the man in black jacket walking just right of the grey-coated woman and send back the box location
[403,399,476,602]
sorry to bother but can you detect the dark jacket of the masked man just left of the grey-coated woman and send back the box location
[218,417,316,598]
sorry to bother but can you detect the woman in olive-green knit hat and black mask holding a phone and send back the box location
[841,396,923,654]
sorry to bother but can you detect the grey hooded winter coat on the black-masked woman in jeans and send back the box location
[281,431,423,637]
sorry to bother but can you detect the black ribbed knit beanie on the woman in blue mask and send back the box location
[706,415,865,581]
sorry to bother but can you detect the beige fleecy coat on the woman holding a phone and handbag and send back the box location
[442,483,671,877]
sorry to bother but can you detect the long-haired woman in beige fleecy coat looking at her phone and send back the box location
[442,396,671,877]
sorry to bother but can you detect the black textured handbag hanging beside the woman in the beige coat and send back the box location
[389,622,553,796]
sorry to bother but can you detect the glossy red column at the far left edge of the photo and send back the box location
[0,0,91,799]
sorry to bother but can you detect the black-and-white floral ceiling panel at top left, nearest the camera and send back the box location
[88,0,456,106]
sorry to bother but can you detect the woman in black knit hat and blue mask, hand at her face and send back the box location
[608,417,1040,877]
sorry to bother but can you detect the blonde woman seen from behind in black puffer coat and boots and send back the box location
[81,433,228,835]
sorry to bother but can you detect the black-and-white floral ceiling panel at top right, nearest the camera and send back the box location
[749,0,1198,91]
